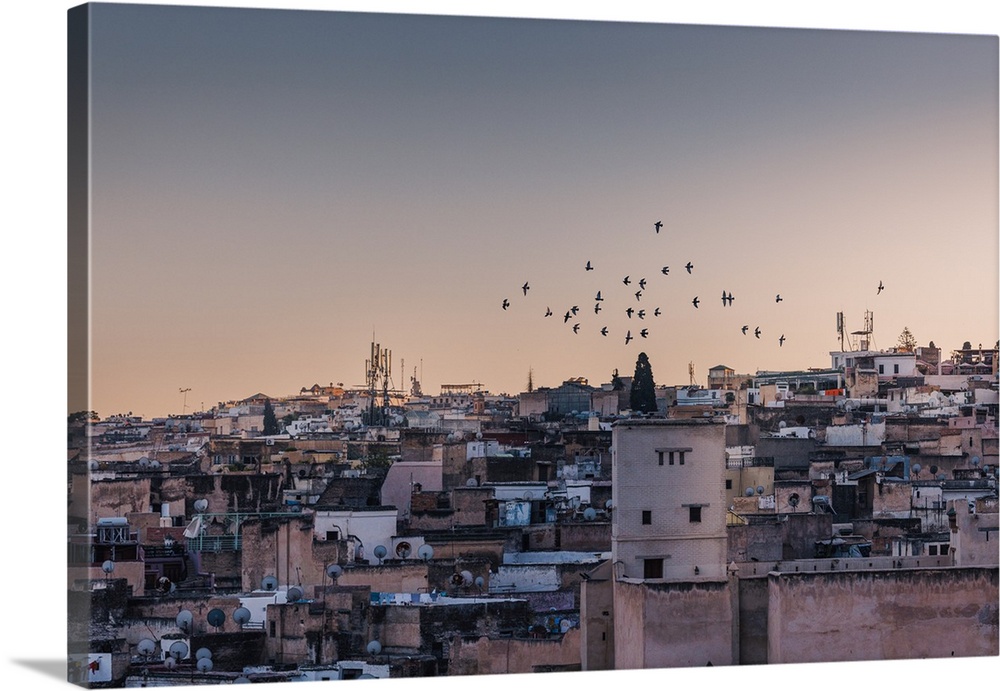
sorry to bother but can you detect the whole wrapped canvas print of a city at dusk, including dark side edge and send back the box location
[67,3,1000,688]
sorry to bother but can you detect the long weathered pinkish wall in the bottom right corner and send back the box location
[768,568,998,663]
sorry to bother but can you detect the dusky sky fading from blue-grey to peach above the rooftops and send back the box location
[80,5,998,416]
